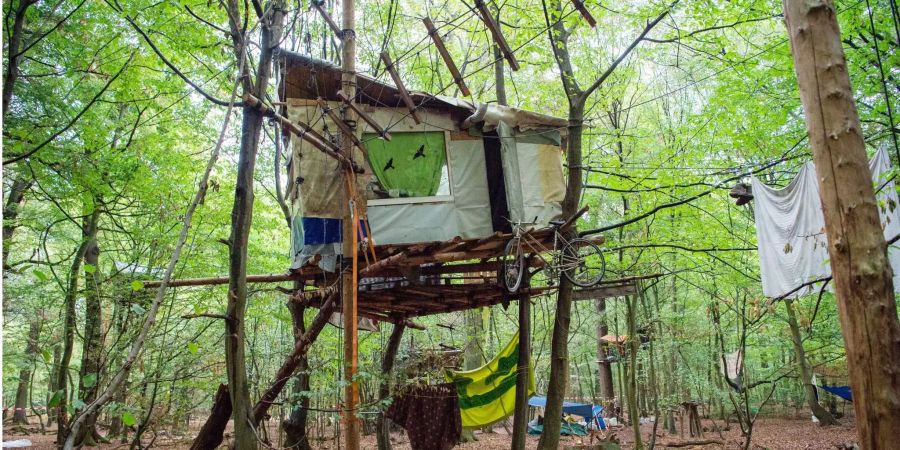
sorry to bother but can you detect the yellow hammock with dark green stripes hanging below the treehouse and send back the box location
[446,332,534,428]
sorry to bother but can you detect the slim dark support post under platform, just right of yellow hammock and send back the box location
[512,264,531,450]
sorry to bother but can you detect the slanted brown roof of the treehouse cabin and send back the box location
[278,50,568,134]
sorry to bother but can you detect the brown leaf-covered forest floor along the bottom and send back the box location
[3,418,856,450]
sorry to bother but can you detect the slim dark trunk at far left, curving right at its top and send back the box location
[56,207,100,446]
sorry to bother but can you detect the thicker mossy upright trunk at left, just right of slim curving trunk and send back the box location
[75,213,103,446]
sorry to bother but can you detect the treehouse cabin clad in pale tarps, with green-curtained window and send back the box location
[279,51,567,271]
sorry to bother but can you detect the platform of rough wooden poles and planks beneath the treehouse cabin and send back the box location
[144,221,635,322]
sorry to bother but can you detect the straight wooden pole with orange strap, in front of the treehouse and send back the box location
[341,0,359,450]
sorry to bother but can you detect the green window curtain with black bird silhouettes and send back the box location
[363,131,447,198]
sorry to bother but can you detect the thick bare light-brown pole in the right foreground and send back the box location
[784,0,900,444]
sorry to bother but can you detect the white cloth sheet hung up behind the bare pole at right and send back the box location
[751,147,900,298]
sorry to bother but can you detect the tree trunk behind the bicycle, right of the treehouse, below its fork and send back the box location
[538,102,584,450]
